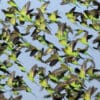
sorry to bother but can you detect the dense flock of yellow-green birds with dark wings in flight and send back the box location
[0,0,100,100]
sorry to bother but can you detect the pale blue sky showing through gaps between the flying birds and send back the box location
[0,0,100,100]
